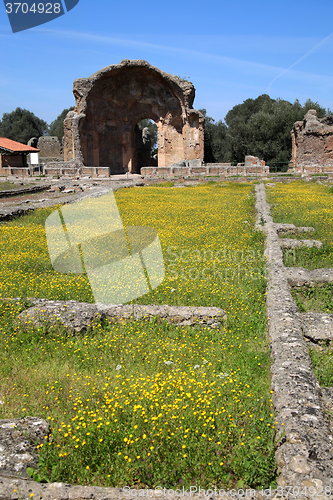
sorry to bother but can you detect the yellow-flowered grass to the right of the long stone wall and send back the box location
[266,181,333,387]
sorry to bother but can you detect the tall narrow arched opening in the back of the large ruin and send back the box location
[134,118,158,173]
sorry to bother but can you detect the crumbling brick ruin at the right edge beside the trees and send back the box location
[291,109,333,172]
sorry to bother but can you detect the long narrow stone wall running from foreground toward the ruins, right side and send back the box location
[256,184,333,492]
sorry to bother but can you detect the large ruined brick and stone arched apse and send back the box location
[64,59,204,174]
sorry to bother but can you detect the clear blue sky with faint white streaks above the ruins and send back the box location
[0,0,333,123]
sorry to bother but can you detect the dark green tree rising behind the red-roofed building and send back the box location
[0,108,48,144]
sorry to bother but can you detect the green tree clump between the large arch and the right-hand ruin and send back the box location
[200,94,330,168]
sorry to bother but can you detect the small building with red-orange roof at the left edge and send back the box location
[0,137,39,175]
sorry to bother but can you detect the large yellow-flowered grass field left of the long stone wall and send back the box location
[0,184,276,488]
